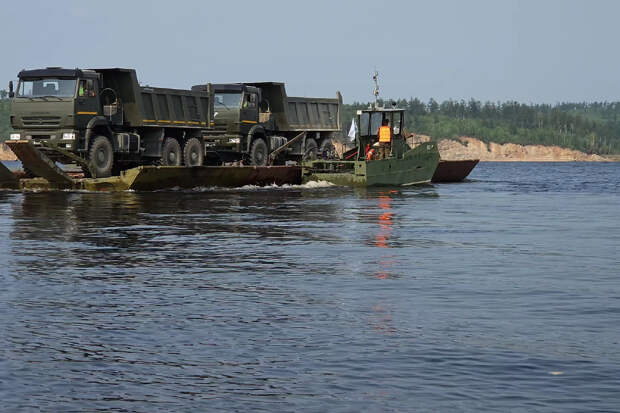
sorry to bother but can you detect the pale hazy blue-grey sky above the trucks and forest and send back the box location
[0,0,620,103]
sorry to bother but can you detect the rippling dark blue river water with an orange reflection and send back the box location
[0,163,620,412]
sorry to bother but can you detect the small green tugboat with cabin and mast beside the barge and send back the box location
[302,72,439,186]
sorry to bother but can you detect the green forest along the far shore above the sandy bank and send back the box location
[0,90,620,154]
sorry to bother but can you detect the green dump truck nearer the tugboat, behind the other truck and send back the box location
[192,82,342,165]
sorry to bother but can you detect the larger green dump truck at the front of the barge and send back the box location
[9,67,213,177]
